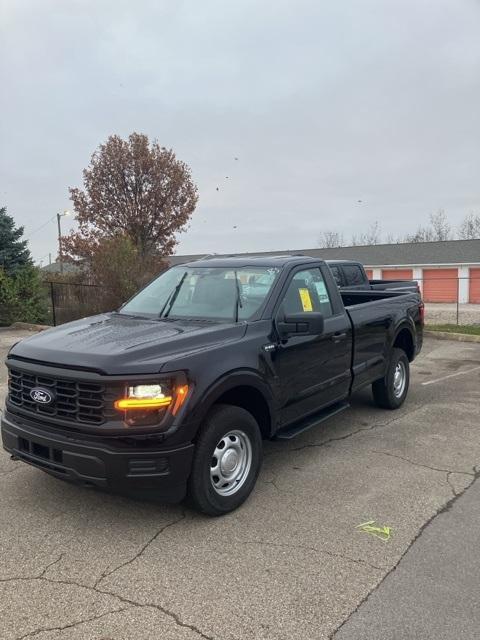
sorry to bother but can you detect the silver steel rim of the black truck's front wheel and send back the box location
[210,429,252,496]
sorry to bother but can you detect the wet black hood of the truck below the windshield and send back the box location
[9,313,246,375]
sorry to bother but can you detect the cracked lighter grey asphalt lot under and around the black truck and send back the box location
[0,331,480,640]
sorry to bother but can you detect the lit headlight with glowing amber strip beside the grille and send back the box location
[114,380,188,427]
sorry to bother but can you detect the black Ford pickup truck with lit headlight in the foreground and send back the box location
[2,256,423,515]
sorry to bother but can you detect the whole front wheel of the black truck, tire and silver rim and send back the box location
[188,404,262,516]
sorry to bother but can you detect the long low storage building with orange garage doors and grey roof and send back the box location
[169,239,480,304]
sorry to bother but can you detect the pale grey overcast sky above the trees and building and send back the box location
[0,0,480,261]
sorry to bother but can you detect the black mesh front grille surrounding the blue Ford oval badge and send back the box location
[8,369,111,424]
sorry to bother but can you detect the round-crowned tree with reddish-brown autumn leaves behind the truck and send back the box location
[62,133,198,284]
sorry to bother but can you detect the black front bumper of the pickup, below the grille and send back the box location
[1,412,193,502]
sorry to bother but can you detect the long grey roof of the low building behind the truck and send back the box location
[168,239,480,267]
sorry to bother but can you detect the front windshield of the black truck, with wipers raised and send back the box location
[120,266,279,320]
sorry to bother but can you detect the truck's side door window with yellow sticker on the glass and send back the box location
[282,268,333,318]
